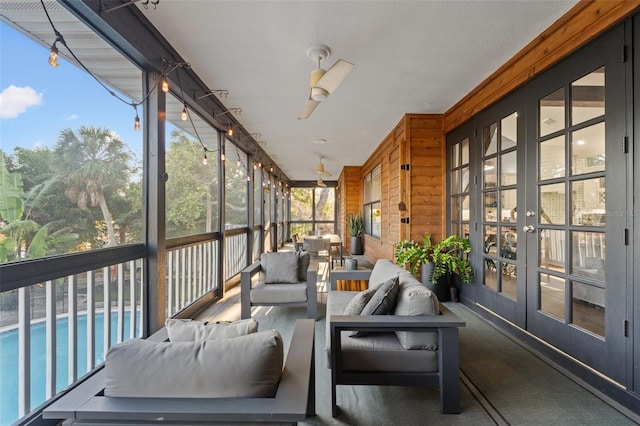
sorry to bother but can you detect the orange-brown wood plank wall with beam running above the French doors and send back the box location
[339,0,640,262]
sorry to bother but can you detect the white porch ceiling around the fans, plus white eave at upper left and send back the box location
[0,0,577,181]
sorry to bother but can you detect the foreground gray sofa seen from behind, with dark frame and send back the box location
[43,319,315,425]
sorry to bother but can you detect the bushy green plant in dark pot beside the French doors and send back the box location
[394,235,473,302]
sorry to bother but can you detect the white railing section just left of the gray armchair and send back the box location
[166,240,220,318]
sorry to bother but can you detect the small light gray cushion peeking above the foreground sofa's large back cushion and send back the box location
[165,318,258,342]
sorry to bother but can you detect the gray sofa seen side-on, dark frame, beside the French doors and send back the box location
[326,259,465,417]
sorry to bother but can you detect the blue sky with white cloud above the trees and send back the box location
[0,22,142,158]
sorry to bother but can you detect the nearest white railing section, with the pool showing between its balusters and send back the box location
[0,258,145,424]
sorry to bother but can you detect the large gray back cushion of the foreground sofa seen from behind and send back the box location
[104,330,284,398]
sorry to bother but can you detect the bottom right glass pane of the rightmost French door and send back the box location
[571,281,605,337]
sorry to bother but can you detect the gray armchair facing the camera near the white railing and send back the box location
[240,251,318,319]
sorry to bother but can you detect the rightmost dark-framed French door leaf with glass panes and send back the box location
[518,27,633,383]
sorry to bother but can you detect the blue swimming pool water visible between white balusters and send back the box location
[0,312,140,426]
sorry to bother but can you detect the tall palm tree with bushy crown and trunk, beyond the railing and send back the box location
[55,126,131,246]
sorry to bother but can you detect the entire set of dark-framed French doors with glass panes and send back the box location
[447,26,633,383]
